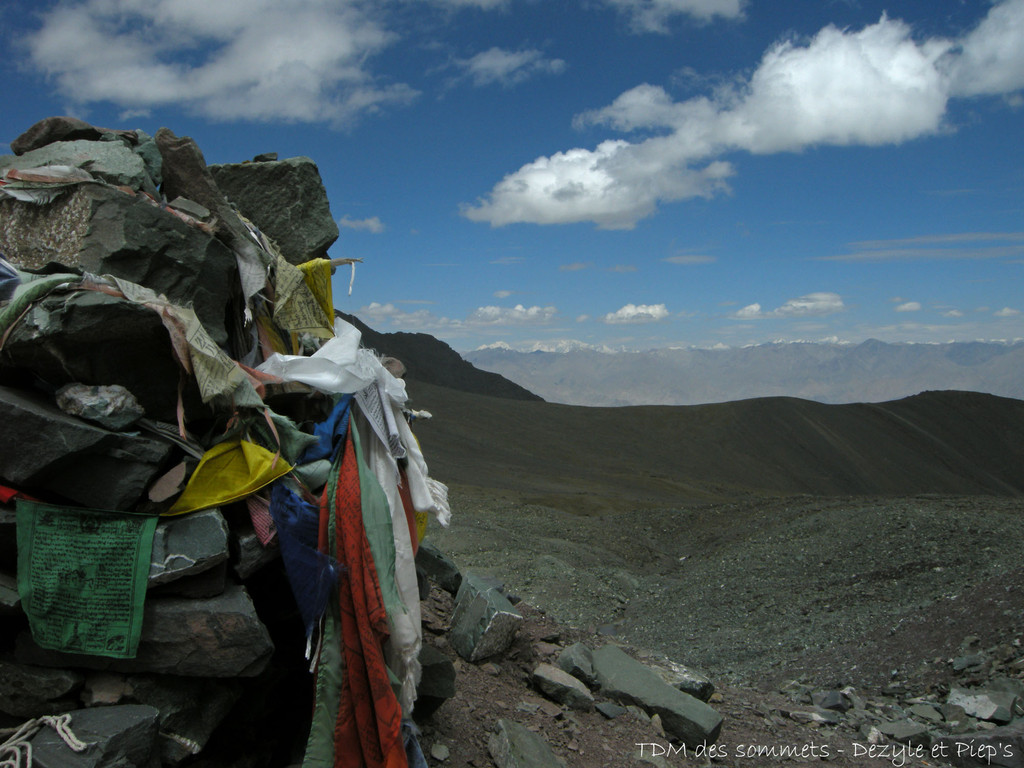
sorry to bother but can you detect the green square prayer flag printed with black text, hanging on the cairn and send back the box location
[17,499,157,658]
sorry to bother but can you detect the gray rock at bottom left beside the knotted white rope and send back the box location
[31,705,160,768]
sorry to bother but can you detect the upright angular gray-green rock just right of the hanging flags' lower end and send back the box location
[450,572,523,662]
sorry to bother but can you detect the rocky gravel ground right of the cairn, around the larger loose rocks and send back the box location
[413,487,1024,768]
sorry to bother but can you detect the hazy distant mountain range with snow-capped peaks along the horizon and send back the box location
[463,339,1024,406]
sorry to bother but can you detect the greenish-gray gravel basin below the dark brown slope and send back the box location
[430,488,1024,683]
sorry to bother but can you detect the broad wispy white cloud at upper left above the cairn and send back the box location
[26,0,416,125]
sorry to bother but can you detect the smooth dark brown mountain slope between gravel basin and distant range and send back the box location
[411,384,1024,512]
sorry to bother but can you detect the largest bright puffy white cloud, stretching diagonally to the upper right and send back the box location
[462,0,1024,229]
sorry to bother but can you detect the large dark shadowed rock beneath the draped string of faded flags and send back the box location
[0,288,197,424]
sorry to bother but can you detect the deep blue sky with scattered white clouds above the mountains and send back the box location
[0,0,1024,350]
